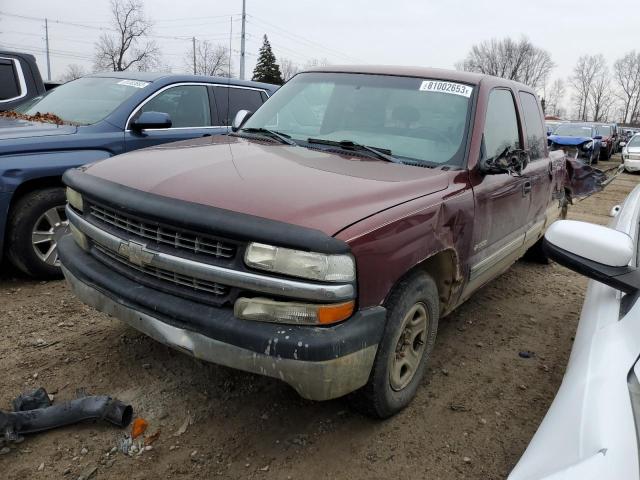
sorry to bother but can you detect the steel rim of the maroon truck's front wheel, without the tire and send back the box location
[389,302,429,392]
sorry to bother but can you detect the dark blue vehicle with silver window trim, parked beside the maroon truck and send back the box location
[0,72,278,278]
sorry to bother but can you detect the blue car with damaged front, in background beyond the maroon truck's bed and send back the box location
[548,123,602,165]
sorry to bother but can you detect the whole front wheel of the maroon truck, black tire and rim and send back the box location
[349,272,440,419]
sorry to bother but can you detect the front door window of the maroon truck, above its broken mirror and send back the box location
[484,89,520,158]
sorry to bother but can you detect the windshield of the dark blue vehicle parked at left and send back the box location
[15,77,149,125]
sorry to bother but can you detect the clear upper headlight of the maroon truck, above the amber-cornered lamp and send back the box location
[244,243,356,282]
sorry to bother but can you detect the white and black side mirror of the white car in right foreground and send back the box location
[543,220,640,293]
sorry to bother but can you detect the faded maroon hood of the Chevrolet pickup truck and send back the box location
[86,136,451,235]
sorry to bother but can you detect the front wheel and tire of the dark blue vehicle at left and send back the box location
[7,187,68,279]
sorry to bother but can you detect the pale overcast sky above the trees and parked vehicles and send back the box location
[0,0,640,106]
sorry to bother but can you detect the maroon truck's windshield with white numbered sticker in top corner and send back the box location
[243,72,473,166]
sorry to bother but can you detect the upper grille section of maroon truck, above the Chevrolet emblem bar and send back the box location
[89,203,236,259]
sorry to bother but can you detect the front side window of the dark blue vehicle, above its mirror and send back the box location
[138,85,211,128]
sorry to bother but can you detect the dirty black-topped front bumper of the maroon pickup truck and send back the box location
[58,236,386,400]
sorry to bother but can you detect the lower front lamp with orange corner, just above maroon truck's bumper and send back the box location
[233,297,355,325]
